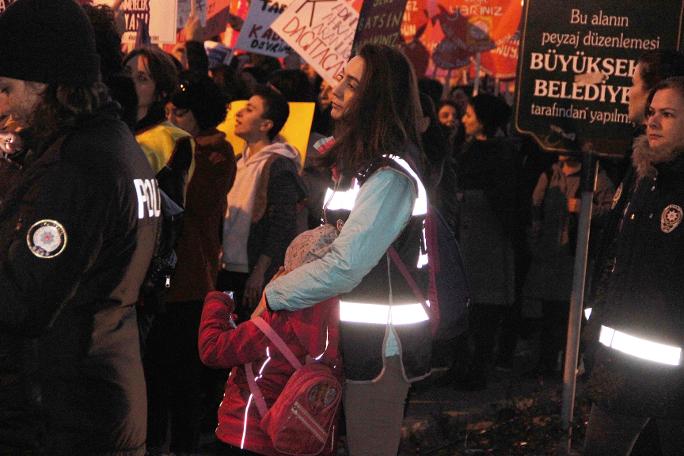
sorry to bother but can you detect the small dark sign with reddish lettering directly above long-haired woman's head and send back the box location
[353,0,406,51]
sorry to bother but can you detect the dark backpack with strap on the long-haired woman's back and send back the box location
[388,205,470,340]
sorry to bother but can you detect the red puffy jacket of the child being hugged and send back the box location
[199,292,341,456]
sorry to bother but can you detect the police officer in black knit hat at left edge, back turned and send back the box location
[0,0,160,455]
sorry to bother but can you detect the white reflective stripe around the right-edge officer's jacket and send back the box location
[599,325,682,366]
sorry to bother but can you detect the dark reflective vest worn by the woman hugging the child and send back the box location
[324,156,432,381]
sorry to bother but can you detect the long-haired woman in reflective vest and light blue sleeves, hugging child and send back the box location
[255,45,431,455]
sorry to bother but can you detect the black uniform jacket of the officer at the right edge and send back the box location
[589,148,684,419]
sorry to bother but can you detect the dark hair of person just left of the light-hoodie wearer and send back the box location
[171,71,226,130]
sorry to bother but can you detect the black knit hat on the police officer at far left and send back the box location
[0,0,100,86]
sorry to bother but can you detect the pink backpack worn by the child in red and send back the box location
[245,318,342,456]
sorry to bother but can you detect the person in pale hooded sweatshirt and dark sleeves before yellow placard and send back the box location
[218,87,305,318]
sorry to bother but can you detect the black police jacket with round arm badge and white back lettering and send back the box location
[0,108,159,455]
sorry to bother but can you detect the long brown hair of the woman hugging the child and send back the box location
[322,44,421,177]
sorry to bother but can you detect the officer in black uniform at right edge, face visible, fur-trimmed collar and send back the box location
[584,77,684,456]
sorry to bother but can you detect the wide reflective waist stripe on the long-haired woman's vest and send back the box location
[340,301,429,325]
